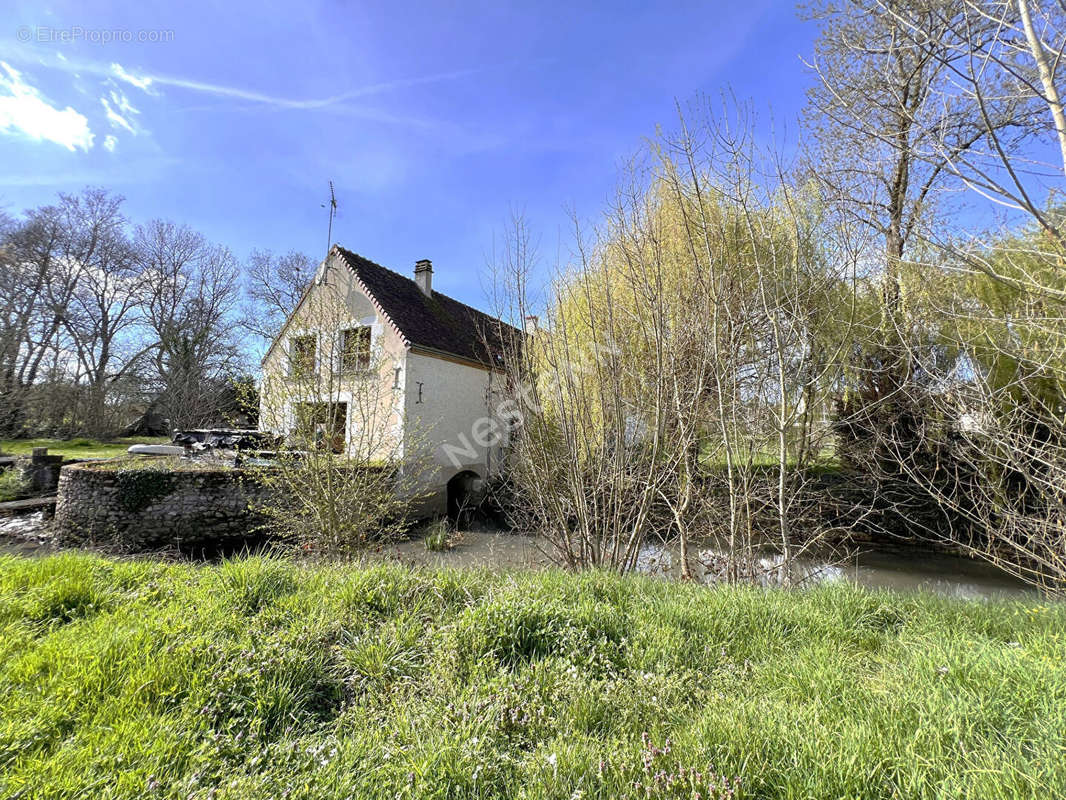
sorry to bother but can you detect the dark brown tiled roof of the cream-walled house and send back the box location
[334,245,520,365]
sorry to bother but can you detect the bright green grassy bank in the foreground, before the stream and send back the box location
[0,555,1066,800]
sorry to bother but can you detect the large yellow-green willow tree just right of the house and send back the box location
[498,108,847,580]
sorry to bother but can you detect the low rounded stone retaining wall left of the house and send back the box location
[53,461,265,553]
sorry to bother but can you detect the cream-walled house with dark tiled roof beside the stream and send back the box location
[260,245,518,514]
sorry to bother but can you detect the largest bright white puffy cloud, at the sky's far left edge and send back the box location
[0,61,93,153]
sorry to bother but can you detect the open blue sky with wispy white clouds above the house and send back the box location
[0,0,813,304]
